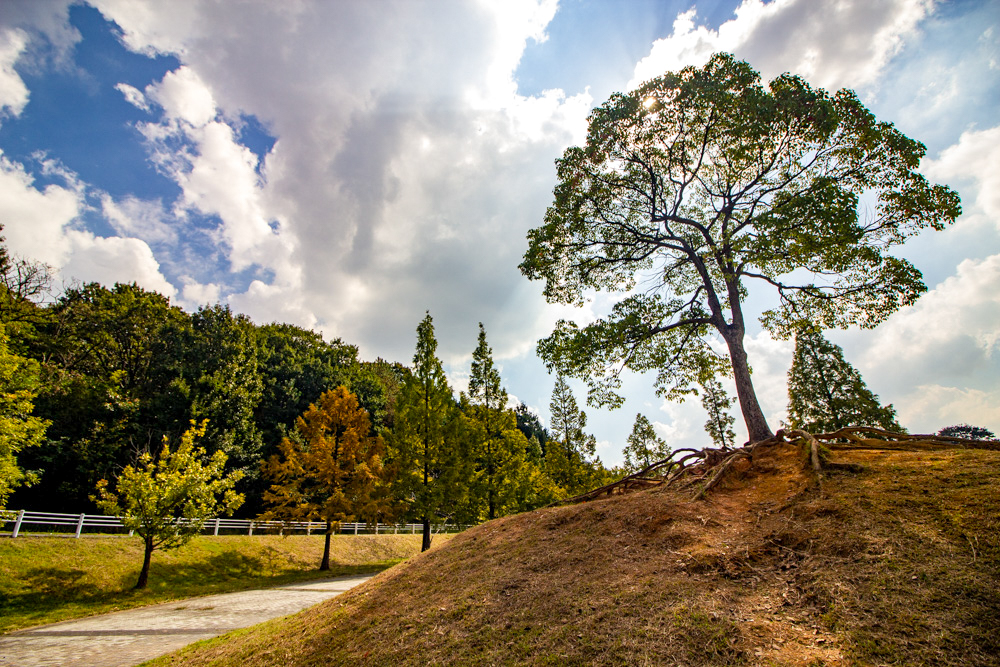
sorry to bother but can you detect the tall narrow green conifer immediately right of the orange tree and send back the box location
[393,313,471,551]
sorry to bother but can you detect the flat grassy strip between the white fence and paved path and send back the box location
[0,535,440,632]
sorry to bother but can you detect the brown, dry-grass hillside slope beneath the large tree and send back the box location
[150,445,1000,667]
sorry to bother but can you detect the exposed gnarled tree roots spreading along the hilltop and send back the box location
[547,426,1000,507]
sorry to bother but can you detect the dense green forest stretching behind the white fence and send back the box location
[0,230,613,523]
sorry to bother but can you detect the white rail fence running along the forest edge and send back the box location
[0,510,466,537]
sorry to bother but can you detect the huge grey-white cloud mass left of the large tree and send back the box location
[86,0,591,361]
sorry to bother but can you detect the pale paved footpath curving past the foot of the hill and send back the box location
[0,575,373,667]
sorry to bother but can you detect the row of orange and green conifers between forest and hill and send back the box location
[264,314,611,556]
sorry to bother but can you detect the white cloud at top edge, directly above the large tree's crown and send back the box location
[629,0,933,89]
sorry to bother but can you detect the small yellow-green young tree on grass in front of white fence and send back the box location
[94,421,243,589]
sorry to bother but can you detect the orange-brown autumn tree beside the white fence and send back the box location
[262,387,385,570]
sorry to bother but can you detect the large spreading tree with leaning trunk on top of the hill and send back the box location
[520,54,960,441]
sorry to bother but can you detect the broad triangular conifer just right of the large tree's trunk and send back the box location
[788,328,904,433]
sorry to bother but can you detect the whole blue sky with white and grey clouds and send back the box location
[0,0,1000,463]
